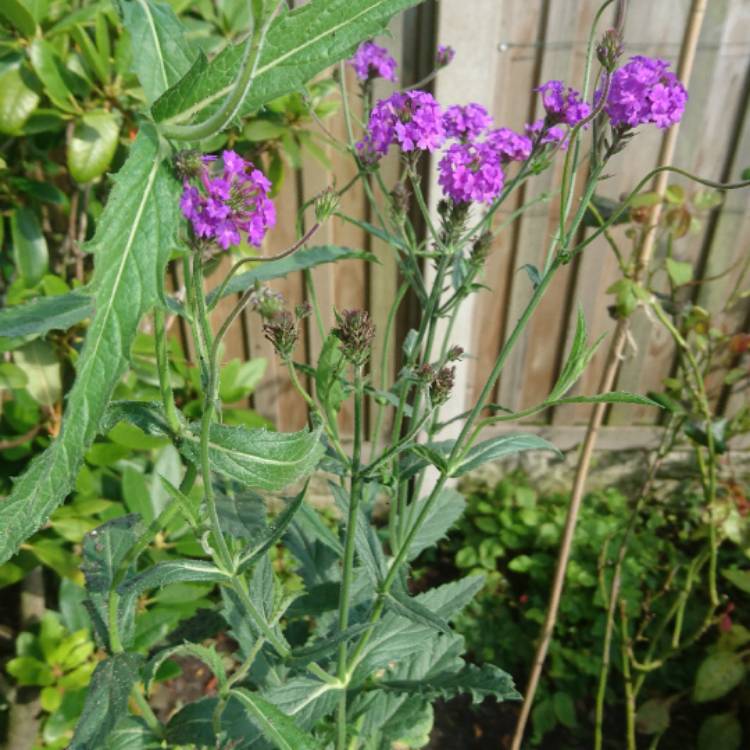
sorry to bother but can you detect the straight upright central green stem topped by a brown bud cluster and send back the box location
[336,365,364,750]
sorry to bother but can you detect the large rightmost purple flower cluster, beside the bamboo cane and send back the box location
[597,55,688,128]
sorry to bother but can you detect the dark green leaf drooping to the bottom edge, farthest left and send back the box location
[69,653,143,750]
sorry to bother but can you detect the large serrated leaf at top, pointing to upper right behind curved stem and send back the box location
[151,0,420,124]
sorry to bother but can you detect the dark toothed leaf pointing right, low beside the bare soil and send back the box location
[380,664,522,704]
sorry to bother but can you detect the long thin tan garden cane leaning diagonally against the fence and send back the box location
[511,0,707,750]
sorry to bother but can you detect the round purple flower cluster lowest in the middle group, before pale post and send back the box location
[438,142,505,203]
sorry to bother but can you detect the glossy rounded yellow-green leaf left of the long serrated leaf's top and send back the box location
[67,109,120,183]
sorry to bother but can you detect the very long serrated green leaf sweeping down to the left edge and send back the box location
[0,127,180,562]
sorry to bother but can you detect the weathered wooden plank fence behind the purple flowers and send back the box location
[181,0,750,446]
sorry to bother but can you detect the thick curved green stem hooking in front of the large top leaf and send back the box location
[159,3,281,141]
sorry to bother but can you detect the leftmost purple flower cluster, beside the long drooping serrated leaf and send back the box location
[180,151,276,250]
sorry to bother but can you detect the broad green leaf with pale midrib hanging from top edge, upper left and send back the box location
[119,0,196,104]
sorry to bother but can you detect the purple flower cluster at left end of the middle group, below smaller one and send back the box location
[357,91,445,163]
